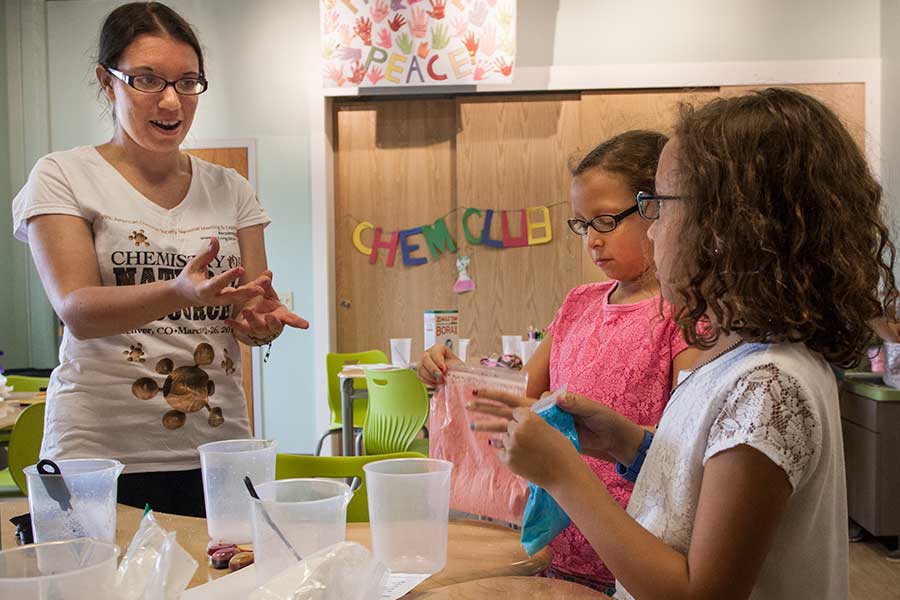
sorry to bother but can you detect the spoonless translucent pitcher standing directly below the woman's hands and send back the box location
[197,439,277,544]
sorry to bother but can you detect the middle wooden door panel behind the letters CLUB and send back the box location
[456,93,583,356]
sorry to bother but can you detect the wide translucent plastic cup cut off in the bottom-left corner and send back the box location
[0,536,119,600]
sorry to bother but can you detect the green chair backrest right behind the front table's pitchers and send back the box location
[275,452,425,523]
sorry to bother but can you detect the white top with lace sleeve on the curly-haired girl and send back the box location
[615,344,848,600]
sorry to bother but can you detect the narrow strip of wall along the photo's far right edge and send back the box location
[881,0,900,278]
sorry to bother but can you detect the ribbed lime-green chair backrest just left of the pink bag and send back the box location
[363,369,428,454]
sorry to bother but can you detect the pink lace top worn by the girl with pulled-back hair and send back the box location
[549,281,687,587]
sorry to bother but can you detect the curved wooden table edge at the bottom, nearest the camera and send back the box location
[406,577,609,600]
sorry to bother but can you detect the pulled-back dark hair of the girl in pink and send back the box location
[570,129,669,194]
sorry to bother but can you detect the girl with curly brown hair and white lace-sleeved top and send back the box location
[471,89,897,600]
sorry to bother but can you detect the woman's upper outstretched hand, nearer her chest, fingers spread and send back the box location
[174,238,265,306]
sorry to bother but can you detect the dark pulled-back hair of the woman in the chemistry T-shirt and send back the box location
[97,2,206,75]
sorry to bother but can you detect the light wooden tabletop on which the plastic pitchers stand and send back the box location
[0,500,552,591]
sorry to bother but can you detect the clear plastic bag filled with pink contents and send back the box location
[428,365,528,525]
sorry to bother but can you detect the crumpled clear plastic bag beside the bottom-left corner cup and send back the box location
[116,511,197,600]
